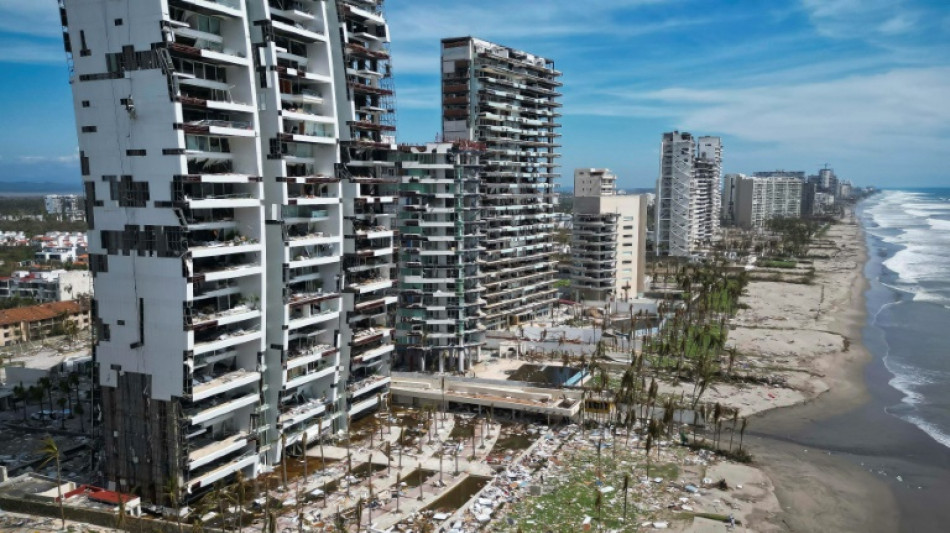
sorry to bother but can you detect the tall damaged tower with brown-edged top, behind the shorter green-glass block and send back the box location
[441,37,561,329]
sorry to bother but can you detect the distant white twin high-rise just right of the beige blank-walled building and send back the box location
[656,131,722,257]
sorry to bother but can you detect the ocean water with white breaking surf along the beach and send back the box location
[858,188,950,447]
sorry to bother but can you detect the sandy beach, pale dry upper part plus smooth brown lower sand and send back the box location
[705,223,898,531]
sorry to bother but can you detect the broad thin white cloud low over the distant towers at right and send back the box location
[592,67,950,180]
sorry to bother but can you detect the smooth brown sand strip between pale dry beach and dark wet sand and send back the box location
[750,218,899,532]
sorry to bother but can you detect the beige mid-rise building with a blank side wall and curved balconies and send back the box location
[571,168,647,301]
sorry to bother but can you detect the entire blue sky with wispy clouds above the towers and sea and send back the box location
[0,0,950,187]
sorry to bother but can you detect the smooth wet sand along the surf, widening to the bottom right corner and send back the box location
[748,218,950,532]
